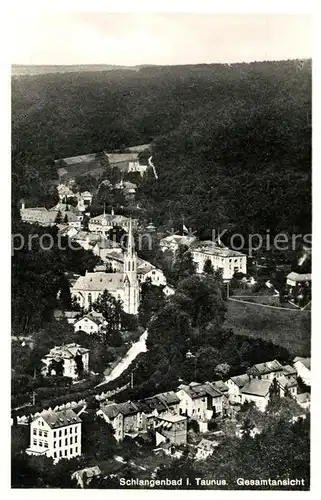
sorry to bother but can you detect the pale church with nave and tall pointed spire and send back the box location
[70,219,140,315]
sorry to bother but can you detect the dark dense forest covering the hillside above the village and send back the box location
[12,60,311,238]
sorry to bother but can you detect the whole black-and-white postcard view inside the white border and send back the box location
[7,2,310,494]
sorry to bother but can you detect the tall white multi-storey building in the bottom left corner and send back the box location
[26,409,81,461]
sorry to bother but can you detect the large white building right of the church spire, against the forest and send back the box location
[191,241,247,280]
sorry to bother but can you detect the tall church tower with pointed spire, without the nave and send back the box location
[124,218,139,315]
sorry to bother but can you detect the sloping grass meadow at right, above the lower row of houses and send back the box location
[224,299,311,356]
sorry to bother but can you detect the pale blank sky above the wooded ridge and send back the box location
[10,12,312,66]
